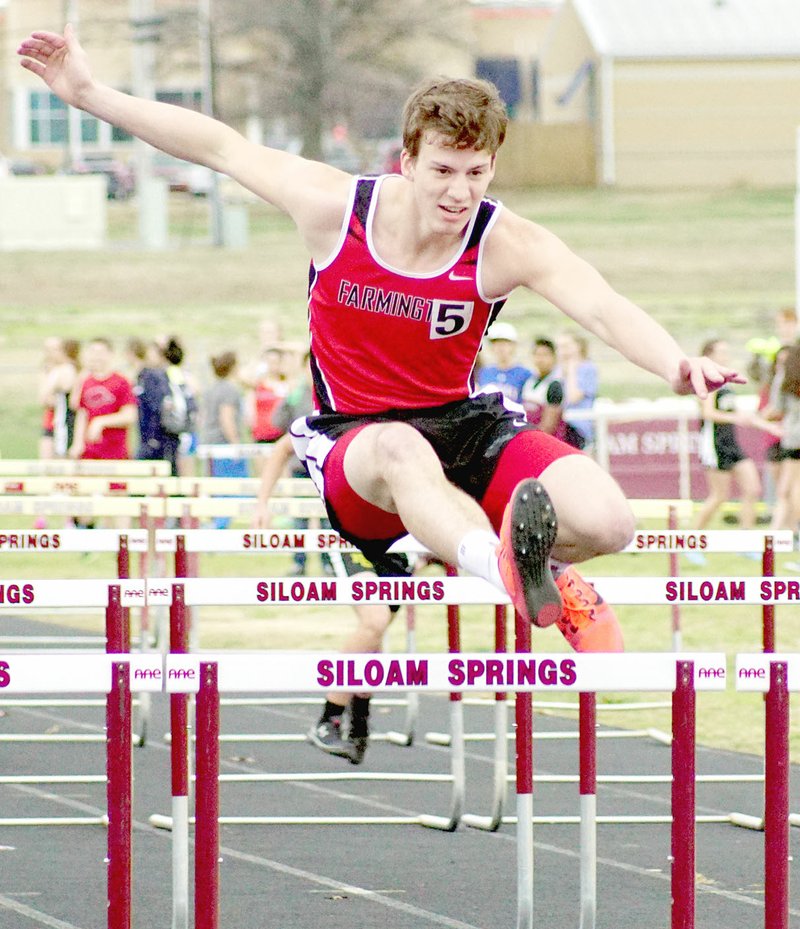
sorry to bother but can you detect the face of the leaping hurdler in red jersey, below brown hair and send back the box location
[400,136,495,234]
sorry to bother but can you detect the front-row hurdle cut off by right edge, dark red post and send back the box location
[736,653,800,929]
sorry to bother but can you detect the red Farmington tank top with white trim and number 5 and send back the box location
[309,177,505,414]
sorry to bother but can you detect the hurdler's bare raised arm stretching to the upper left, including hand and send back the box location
[17,25,350,252]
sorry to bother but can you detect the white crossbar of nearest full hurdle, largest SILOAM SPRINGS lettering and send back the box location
[166,652,727,693]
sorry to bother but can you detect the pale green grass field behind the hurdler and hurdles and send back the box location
[0,183,800,759]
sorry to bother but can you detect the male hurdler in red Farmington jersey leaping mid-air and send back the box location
[18,26,743,651]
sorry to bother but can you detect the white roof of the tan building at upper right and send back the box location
[572,0,800,58]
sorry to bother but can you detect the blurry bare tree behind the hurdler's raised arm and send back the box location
[209,0,468,158]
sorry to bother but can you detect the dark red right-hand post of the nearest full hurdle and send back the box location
[671,661,696,929]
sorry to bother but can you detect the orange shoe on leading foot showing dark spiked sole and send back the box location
[497,478,562,626]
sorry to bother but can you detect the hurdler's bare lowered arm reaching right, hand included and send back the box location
[484,211,745,398]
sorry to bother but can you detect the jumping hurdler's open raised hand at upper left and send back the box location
[17,23,93,107]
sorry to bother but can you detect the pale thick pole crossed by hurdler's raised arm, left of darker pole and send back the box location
[130,0,168,248]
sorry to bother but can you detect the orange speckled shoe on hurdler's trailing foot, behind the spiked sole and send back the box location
[556,566,625,652]
